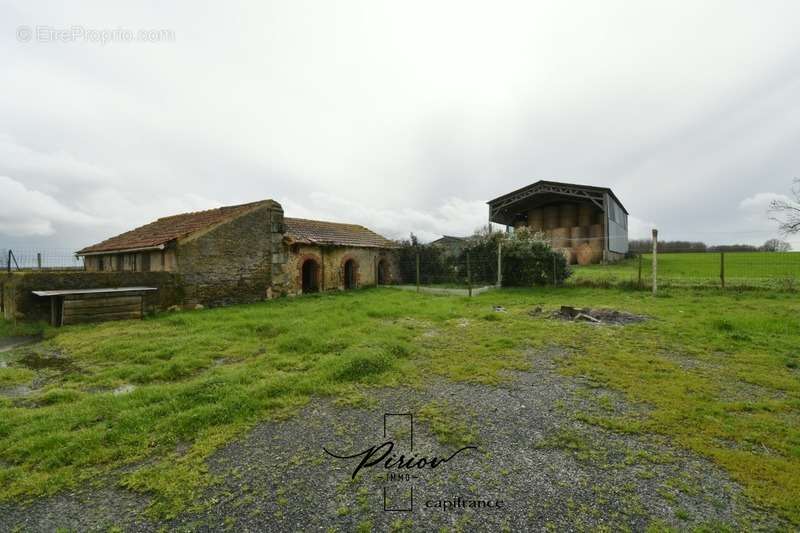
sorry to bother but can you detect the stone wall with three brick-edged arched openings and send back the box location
[284,244,399,294]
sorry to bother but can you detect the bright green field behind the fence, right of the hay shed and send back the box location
[571,252,800,289]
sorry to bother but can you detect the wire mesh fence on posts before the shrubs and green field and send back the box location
[399,237,800,292]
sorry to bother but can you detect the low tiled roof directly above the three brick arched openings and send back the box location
[283,217,397,248]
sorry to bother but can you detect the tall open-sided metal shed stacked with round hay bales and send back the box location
[488,180,628,264]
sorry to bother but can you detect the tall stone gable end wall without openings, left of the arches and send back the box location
[176,200,286,306]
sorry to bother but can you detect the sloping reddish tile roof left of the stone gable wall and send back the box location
[76,200,270,255]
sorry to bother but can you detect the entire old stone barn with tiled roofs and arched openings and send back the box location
[76,200,397,306]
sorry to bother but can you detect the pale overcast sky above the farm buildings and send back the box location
[0,0,800,249]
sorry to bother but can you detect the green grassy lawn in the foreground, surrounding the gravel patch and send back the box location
[0,284,800,524]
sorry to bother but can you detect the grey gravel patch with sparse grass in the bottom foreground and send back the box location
[0,350,782,531]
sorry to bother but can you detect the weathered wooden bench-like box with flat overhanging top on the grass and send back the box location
[32,287,158,326]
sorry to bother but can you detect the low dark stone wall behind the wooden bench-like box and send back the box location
[0,271,183,321]
